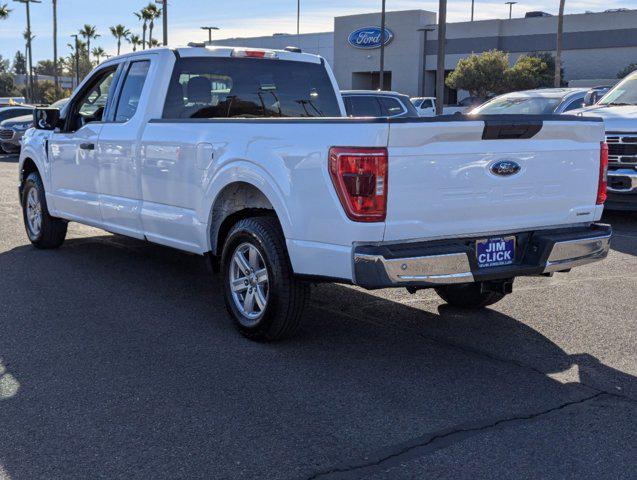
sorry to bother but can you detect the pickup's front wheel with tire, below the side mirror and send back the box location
[22,172,67,249]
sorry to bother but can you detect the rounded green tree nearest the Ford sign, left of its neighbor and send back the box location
[446,50,509,98]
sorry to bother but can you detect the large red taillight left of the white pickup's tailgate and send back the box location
[329,147,388,222]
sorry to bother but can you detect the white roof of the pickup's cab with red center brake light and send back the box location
[104,44,323,63]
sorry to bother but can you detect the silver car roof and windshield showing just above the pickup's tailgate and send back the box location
[470,88,588,115]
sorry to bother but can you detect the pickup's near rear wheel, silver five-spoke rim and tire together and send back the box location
[221,216,309,341]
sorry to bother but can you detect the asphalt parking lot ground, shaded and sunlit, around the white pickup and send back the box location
[0,156,637,480]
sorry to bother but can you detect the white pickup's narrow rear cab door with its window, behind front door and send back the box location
[97,59,152,238]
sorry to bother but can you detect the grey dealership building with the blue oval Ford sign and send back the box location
[212,10,637,103]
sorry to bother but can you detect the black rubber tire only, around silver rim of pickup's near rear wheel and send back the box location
[221,216,309,342]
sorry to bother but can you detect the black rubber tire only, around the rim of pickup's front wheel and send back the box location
[22,172,67,249]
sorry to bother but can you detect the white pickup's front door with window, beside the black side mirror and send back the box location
[47,65,117,224]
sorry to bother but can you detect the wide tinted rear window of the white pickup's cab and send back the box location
[163,58,341,119]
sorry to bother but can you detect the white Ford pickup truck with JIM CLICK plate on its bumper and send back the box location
[19,47,611,340]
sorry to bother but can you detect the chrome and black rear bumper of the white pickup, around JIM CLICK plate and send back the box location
[354,224,612,289]
